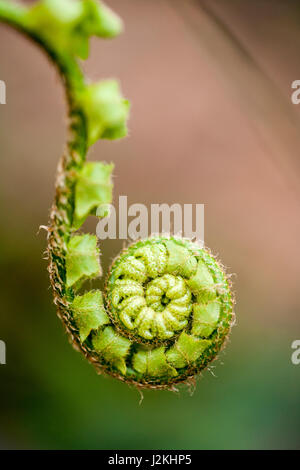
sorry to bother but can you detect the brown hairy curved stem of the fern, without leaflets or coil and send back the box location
[0,0,92,355]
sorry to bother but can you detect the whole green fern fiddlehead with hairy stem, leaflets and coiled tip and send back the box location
[0,0,233,389]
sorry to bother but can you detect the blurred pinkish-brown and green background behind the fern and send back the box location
[0,0,300,449]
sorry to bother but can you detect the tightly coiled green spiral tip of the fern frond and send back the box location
[69,236,233,388]
